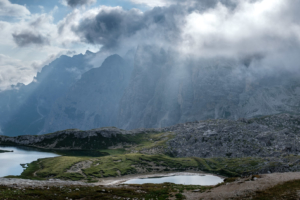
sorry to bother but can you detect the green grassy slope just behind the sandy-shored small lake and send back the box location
[16,153,286,181]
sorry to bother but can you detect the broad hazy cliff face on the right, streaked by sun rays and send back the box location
[118,46,300,129]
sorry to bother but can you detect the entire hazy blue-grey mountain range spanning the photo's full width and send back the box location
[0,45,300,136]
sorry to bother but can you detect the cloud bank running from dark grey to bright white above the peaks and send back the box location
[67,0,300,63]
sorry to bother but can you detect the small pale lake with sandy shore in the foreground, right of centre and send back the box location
[124,175,224,186]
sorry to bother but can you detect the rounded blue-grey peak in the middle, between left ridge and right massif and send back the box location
[44,55,132,133]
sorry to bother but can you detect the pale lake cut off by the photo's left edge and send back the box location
[0,146,59,177]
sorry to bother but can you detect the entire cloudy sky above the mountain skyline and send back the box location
[0,0,300,90]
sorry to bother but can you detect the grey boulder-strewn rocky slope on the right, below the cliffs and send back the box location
[168,114,300,158]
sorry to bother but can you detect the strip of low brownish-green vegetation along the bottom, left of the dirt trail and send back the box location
[0,183,212,200]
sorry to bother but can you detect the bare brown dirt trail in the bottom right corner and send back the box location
[184,172,300,200]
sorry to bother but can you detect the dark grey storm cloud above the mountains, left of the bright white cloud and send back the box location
[73,6,185,49]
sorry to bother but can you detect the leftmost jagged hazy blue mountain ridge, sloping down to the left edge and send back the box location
[0,52,94,136]
